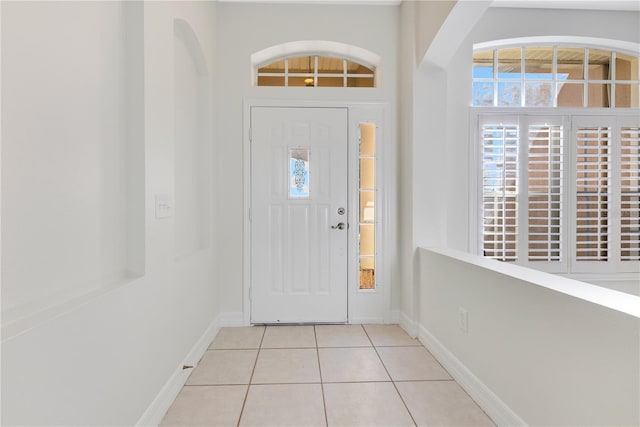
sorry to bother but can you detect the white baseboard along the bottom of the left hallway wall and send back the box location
[136,316,222,427]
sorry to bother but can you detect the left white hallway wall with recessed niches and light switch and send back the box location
[1,2,219,425]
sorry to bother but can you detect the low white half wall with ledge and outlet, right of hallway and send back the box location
[419,249,640,426]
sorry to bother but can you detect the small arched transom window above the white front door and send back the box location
[255,55,375,87]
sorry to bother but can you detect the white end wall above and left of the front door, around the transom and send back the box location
[217,3,398,313]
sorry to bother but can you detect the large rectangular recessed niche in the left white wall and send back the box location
[2,3,138,321]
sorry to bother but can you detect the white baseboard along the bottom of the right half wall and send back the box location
[418,325,527,426]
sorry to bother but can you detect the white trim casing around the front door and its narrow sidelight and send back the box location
[245,99,395,325]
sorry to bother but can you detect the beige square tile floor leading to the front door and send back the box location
[161,325,494,427]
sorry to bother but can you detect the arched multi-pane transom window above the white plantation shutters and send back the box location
[472,45,640,108]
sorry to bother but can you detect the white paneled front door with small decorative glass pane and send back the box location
[250,107,348,323]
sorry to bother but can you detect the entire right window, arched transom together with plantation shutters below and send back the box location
[472,46,640,273]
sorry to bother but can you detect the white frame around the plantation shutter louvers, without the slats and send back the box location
[469,106,640,279]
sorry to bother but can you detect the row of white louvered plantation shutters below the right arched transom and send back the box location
[478,114,640,274]
